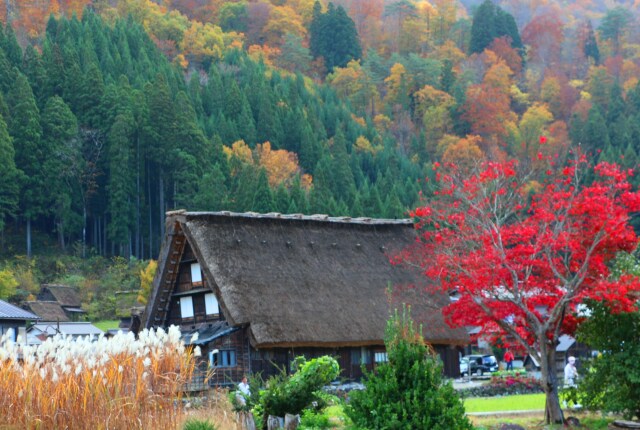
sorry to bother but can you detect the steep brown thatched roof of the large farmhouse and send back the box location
[143,212,468,347]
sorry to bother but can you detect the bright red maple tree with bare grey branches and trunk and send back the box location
[395,150,640,423]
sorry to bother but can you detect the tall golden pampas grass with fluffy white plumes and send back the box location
[0,326,195,430]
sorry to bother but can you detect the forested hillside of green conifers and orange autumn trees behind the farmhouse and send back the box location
[0,0,640,266]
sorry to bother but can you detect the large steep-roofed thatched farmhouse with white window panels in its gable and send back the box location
[141,211,468,384]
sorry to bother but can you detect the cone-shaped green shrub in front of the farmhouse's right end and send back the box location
[346,310,473,430]
